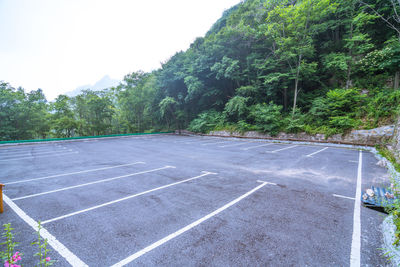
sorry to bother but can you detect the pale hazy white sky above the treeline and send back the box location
[0,0,240,100]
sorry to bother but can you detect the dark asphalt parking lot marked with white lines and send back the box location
[0,134,389,266]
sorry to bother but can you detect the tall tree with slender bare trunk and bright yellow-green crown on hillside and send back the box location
[266,0,336,115]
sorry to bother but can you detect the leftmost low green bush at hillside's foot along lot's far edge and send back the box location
[188,110,225,133]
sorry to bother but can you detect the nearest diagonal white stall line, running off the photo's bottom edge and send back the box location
[111,183,267,267]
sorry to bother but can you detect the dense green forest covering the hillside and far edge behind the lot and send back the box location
[0,0,400,140]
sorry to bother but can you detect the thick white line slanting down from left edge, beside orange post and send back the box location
[3,194,88,267]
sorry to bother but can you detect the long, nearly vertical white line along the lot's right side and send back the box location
[350,150,362,267]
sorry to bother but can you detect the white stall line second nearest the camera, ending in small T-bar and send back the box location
[42,171,216,224]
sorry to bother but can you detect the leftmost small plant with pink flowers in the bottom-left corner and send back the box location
[0,223,22,267]
